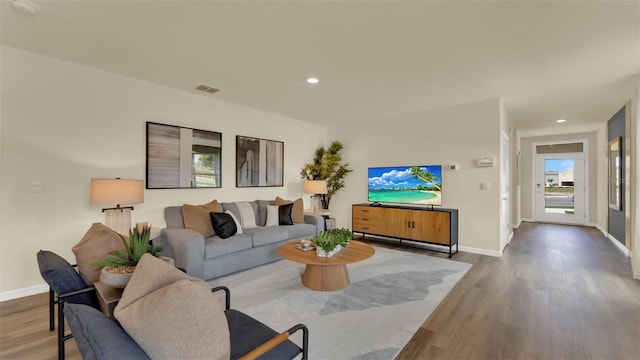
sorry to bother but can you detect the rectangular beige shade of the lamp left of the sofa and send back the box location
[89,179,144,205]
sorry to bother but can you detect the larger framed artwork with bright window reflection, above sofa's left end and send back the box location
[146,122,222,189]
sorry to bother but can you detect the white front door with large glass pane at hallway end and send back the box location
[534,152,586,225]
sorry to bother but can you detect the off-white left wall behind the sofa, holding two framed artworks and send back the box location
[0,46,327,299]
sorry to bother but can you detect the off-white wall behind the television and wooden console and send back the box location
[329,99,501,255]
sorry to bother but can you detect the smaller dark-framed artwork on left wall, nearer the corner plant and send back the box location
[236,135,284,187]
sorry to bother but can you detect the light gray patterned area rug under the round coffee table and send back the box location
[209,247,471,360]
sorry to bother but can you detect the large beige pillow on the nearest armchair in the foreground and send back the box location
[114,254,231,359]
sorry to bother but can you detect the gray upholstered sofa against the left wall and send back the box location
[159,200,324,280]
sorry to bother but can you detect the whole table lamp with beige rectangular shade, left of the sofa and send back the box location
[89,178,144,234]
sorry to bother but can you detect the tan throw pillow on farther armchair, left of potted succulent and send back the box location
[71,223,124,285]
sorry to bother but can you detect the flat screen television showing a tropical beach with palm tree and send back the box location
[368,165,442,205]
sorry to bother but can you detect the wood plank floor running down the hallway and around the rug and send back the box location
[0,223,640,360]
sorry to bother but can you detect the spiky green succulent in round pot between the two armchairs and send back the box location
[91,225,165,287]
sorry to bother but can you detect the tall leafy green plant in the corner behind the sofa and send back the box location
[300,140,353,209]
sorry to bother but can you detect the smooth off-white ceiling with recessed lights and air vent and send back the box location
[0,0,640,132]
